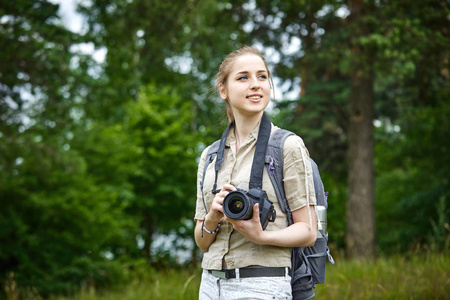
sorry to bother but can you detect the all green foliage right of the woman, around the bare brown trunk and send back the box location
[244,0,450,253]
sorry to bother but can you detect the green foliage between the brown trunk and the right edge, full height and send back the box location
[376,1,450,253]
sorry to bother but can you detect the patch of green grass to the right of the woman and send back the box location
[315,254,450,299]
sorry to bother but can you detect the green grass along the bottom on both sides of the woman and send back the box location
[51,253,450,300]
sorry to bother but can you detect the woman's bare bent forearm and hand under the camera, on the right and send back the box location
[225,204,317,247]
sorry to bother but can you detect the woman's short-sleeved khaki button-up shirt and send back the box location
[195,124,316,270]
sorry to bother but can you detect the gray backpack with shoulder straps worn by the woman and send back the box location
[200,118,334,300]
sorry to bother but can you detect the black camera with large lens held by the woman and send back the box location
[222,188,276,230]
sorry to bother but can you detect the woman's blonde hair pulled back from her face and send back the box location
[214,46,273,122]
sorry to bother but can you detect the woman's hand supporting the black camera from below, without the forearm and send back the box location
[225,203,265,244]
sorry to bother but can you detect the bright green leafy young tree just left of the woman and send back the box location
[126,85,198,258]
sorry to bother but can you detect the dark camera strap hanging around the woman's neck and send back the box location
[212,113,272,194]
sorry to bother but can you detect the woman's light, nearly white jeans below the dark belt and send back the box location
[199,270,292,300]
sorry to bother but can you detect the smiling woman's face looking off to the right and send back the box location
[219,54,270,117]
